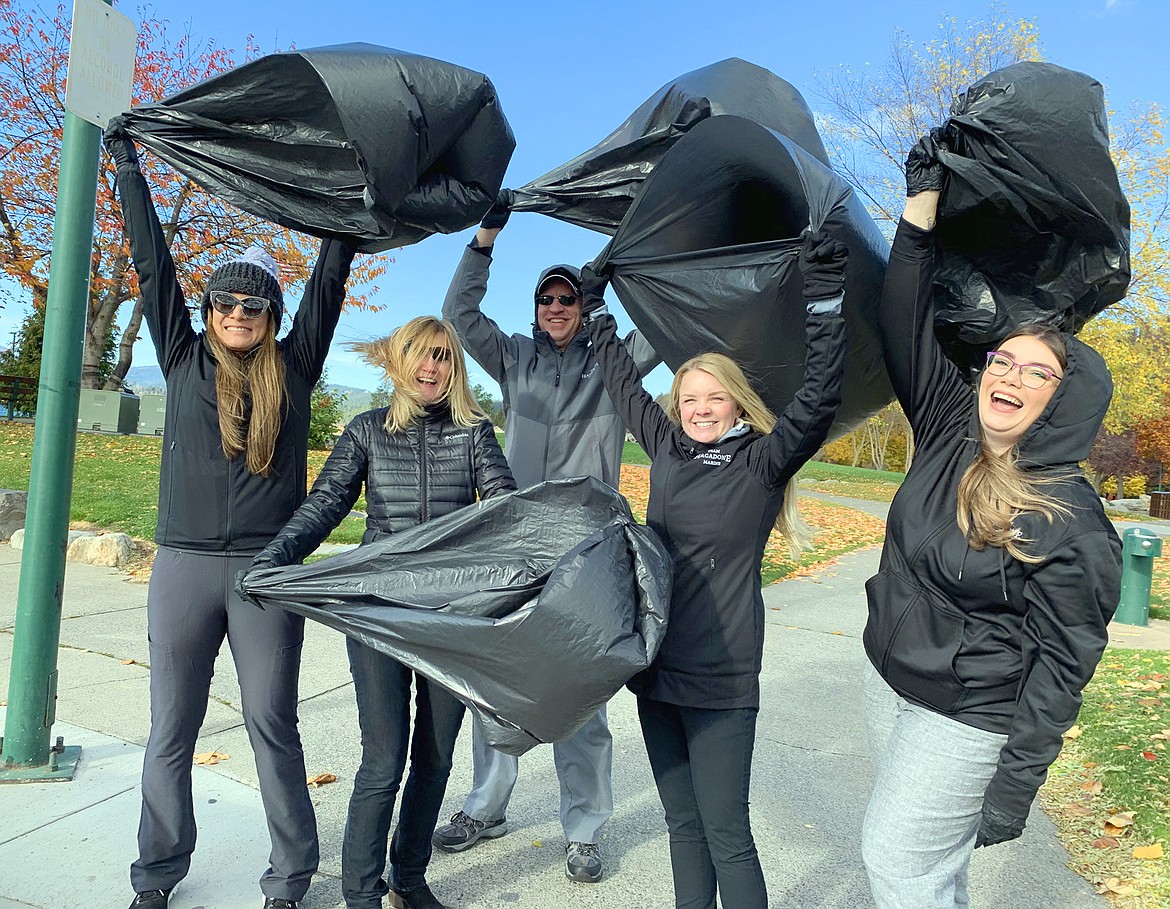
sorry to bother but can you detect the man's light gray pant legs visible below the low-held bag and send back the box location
[463,707,613,842]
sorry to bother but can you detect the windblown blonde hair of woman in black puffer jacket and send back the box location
[349,316,488,433]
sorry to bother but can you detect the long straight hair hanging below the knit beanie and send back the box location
[207,317,284,476]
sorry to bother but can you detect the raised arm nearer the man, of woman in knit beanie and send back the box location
[284,239,357,385]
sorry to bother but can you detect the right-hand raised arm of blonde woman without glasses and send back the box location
[759,230,848,486]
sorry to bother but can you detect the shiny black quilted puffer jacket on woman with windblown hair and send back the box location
[256,405,516,565]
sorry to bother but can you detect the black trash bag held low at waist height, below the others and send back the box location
[246,477,672,755]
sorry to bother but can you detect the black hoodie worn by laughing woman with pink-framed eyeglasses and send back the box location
[865,221,1121,817]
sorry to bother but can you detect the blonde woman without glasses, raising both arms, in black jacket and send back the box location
[581,226,847,909]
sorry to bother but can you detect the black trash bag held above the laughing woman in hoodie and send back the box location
[935,63,1129,366]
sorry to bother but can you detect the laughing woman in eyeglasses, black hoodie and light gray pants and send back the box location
[862,133,1121,909]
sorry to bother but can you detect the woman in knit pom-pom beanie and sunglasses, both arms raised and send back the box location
[105,124,355,909]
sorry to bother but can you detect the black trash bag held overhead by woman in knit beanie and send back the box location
[125,43,516,253]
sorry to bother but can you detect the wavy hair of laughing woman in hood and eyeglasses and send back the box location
[956,325,1072,556]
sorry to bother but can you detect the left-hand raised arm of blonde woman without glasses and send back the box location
[581,266,673,460]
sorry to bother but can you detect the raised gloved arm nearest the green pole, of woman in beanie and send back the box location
[104,117,197,376]
